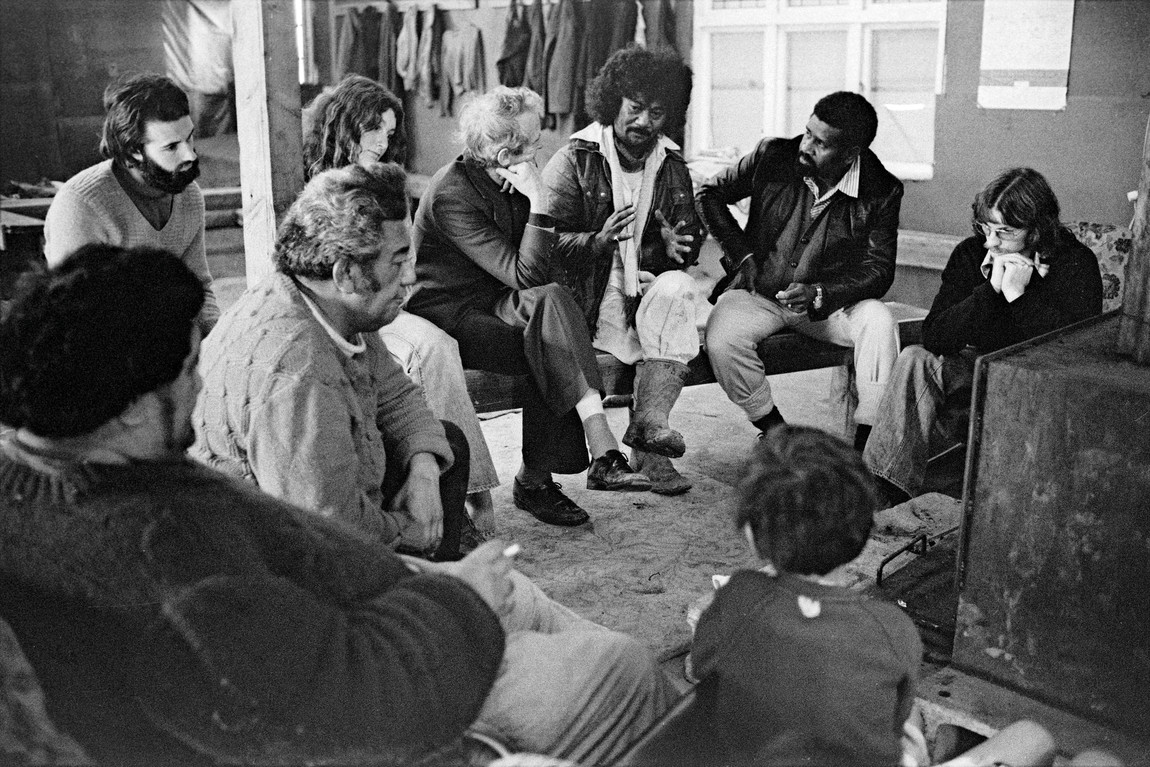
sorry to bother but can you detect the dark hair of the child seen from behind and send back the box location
[735,425,876,575]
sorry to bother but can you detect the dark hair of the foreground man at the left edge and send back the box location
[0,244,204,438]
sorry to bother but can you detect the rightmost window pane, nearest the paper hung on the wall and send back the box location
[871,29,938,163]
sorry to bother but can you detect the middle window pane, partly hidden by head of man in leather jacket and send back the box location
[783,30,846,136]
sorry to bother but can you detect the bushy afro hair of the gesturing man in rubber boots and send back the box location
[587,44,692,133]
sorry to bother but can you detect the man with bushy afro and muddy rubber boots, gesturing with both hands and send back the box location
[543,46,711,494]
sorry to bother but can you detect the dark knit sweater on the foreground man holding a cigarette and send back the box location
[0,437,504,765]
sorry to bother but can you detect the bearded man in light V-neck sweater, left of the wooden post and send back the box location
[44,75,220,336]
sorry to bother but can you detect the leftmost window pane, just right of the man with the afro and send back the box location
[711,32,764,152]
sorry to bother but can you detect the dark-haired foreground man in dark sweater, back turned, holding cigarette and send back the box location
[0,245,673,767]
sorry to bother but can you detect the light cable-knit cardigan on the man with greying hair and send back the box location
[191,274,453,544]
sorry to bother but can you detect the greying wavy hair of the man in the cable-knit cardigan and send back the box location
[271,162,407,279]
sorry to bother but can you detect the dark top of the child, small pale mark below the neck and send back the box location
[691,570,922,767]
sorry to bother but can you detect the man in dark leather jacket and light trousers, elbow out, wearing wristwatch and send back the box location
[698,91,903,448]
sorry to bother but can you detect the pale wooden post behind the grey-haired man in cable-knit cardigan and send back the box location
[231,0,304,285]
